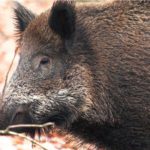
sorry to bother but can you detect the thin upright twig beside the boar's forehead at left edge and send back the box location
[1,47,19,100]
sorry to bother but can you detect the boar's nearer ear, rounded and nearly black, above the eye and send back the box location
[48,0,76,39]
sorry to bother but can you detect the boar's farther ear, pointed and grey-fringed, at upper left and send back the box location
[14,2,35,32]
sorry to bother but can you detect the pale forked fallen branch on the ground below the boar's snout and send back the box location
[0,122,54,150]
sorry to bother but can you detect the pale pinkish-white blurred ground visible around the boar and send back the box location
[0,0,105,150]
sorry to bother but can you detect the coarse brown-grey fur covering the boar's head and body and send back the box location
[1,0,150,150]
